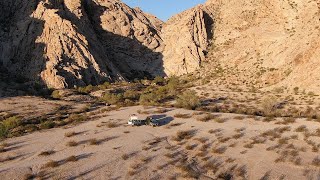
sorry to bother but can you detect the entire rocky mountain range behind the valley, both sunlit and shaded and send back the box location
[0,0,320,90]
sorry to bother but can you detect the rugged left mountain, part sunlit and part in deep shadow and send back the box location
[0,0,163,88]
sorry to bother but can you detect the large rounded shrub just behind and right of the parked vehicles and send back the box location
[176,91,200,110]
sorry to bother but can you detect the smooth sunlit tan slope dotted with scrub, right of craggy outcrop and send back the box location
[205,0,320,90]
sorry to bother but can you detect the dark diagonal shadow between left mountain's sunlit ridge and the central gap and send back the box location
[52,0,165,85]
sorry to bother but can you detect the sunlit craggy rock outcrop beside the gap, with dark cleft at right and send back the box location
[161,5,214,75]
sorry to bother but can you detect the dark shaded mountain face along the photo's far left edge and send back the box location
[0,0,46,97]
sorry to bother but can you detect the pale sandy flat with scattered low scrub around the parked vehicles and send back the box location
[0,100,320,179]
